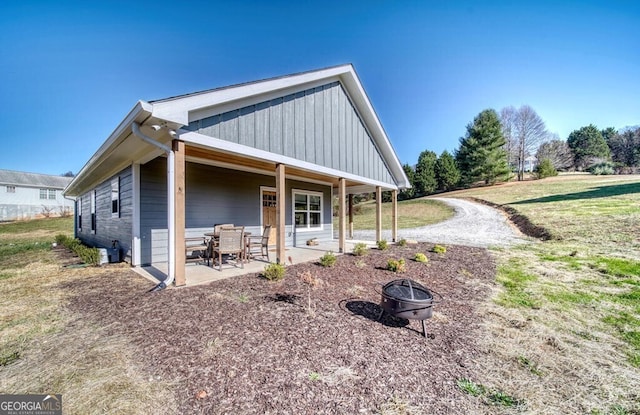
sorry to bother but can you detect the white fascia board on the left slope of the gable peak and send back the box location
[153,65,353,125]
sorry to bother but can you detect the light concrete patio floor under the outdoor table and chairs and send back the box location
[133,240,376,288]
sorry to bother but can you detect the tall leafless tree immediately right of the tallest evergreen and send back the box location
[512,105,549,180]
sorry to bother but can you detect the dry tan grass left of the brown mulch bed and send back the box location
[0,250,177,414]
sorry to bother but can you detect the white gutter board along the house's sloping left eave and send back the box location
[62,101,152,196]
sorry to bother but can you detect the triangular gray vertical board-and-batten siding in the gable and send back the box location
[186,82,395,185]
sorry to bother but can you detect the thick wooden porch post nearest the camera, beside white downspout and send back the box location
[172,140,186,286]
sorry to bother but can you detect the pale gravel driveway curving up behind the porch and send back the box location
[353,197,531,248]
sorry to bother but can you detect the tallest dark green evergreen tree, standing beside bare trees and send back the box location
[456,109,509,185]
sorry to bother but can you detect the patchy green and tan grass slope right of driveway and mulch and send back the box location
[446,174,640,414]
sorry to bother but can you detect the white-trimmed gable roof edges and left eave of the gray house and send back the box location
[65,64,410,196]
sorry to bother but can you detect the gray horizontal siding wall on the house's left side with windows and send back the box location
[76,167,133,261]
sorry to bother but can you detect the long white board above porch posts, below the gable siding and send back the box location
[178,130,397,190]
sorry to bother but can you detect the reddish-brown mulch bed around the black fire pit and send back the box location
[62,243,495,414]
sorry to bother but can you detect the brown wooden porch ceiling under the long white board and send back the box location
[185,146,368,191]
